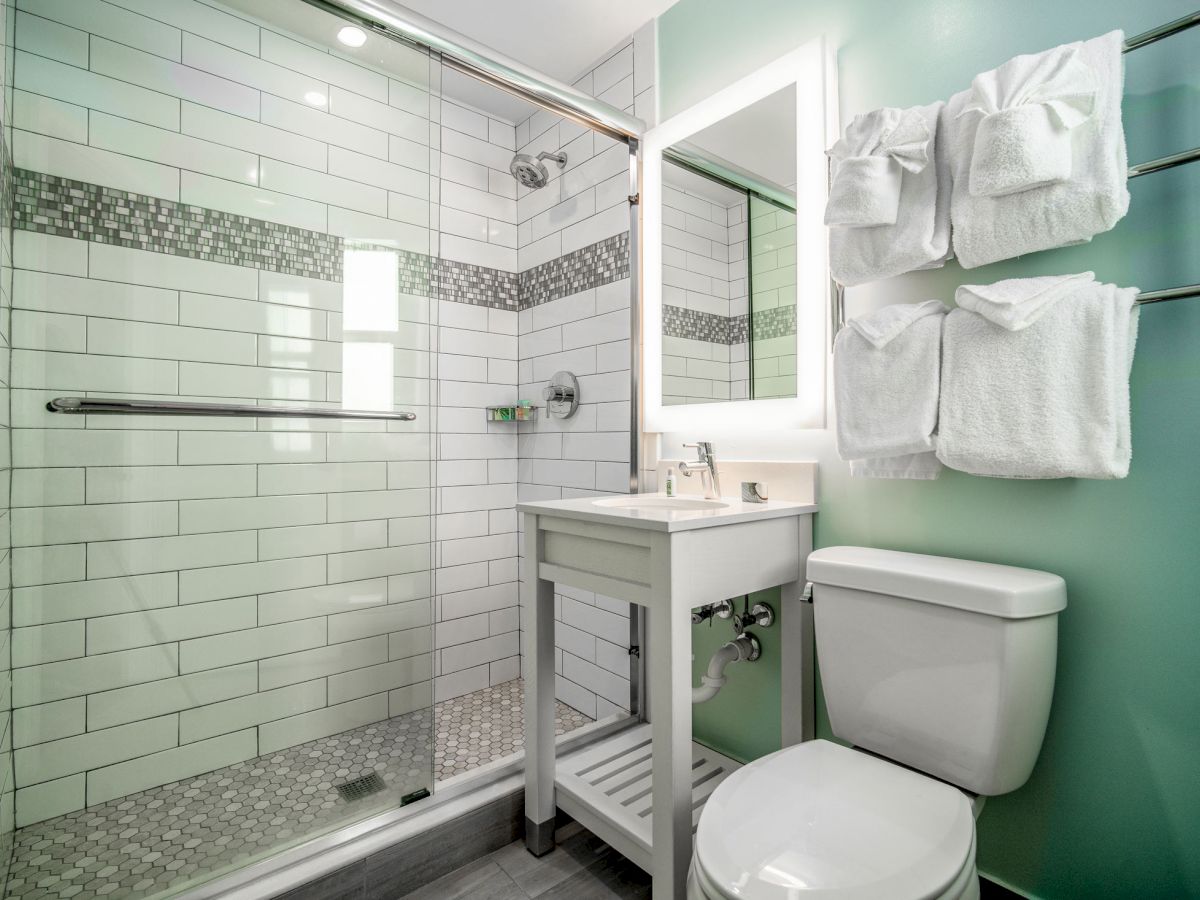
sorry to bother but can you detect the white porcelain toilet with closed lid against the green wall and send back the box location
[688,547,1067,900]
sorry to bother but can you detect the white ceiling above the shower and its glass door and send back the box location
[223,0,676,124]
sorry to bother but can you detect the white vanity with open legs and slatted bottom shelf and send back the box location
[517,494,816,900]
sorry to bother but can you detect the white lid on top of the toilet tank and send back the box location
[808,547,1067,619]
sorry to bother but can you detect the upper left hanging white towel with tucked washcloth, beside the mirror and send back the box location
[826,102,950,286]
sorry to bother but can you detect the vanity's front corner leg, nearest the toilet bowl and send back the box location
[647,582,691,900]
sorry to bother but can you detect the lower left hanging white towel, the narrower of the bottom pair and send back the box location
[834,300,946,478]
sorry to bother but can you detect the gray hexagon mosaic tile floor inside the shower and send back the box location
[5,682,590,900]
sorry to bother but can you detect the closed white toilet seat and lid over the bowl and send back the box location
[694,740,974,900]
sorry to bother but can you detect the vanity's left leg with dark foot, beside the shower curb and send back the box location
[521,514,554,857]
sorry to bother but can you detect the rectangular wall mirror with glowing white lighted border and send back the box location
[643,41,836,431]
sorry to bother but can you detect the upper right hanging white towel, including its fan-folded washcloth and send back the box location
[942,31,1129,269]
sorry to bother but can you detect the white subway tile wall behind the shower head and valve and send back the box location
[516,22,655,718]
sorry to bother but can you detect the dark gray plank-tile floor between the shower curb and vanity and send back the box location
[406,826,650,900]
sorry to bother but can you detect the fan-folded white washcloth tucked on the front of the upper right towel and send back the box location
[959,44,1096,197]
